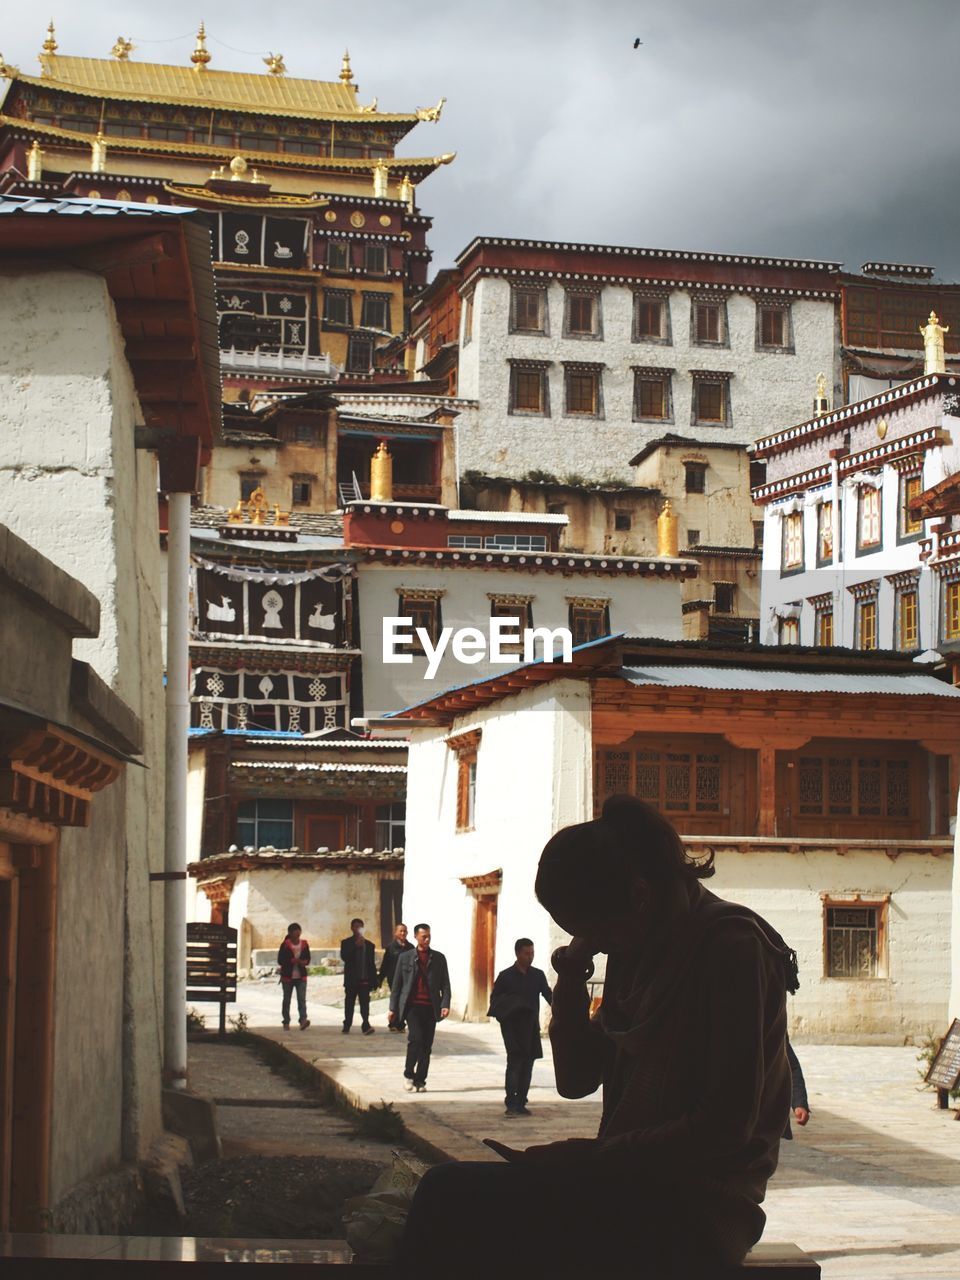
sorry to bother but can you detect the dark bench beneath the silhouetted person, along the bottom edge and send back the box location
[0,1234,820,1280]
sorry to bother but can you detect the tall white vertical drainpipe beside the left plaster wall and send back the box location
[164,493,191,1089]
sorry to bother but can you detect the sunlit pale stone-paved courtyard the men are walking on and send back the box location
[237,979,960,1280]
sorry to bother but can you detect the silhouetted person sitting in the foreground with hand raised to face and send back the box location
[401,796,796,1280]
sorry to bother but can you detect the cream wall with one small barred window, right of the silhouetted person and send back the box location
[705,847,952,1044]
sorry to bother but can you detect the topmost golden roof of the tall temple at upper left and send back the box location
[17,54,417,123]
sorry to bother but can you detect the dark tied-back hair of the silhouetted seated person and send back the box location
[536,795,713,915]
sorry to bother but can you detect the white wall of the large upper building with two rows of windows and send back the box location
[458,276,836,483]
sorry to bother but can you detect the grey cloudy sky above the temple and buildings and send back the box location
[7,0,960,280]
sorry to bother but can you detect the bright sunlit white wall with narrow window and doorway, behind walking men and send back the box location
[403,680,593,1016]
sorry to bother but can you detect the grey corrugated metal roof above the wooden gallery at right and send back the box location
[623,666,960,698]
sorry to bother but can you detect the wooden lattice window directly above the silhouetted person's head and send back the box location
[595,748,727,819]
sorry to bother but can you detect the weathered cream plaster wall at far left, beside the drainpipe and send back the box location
[0,268,164,1203]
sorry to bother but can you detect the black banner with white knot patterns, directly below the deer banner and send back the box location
[191,667,347,733]
